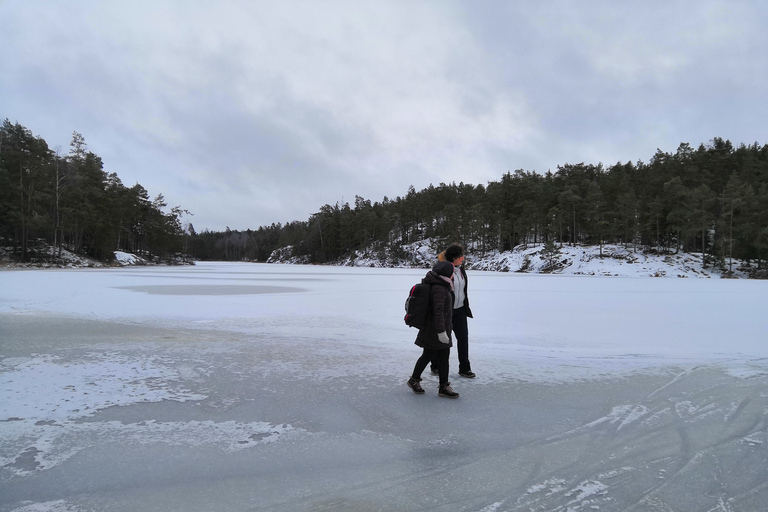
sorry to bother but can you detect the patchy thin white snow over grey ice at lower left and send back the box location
[0,352,295,476]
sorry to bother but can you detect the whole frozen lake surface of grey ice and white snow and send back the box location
[0,263,768,512]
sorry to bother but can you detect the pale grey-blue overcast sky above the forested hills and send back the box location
[0,0,768,231]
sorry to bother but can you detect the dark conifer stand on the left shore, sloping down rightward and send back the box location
[0,119,192,262]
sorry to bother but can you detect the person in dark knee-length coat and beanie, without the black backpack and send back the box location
[408,261,459,398]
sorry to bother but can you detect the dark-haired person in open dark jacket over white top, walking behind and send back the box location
[430,244,476,379]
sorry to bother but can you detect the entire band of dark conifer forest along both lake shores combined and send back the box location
[0,120,768,276]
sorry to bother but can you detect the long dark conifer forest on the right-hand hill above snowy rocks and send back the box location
[190,138,768,267]
